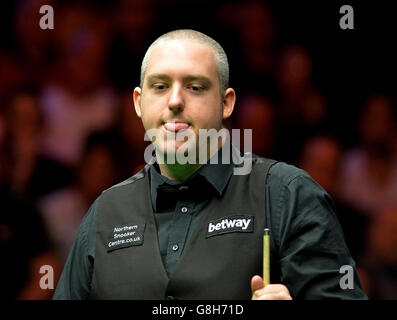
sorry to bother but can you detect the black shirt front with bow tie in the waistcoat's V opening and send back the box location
[149,155,233,275]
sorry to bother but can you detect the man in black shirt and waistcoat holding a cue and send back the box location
[54,30,366,300]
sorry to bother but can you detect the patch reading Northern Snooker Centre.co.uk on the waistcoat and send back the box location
[106,223,145,252]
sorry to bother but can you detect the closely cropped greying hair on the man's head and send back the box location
[140,29,229,96]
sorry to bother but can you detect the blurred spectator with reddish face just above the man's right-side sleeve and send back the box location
[299,135,368,265]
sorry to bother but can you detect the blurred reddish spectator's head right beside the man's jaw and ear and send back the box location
[233,94,277,158]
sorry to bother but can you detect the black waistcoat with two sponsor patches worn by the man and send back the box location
[90,158,274,299]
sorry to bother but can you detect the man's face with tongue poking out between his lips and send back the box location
[134,40,234,160]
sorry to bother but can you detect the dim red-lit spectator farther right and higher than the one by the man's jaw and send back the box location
[277,46,327,164]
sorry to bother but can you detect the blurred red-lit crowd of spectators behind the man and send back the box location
[0,0,397,299]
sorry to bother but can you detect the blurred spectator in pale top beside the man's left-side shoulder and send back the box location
[40,133,119,263]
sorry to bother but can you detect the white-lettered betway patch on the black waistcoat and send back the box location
[206,215,254,238]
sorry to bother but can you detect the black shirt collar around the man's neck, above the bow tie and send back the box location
[149,141,234,208]
